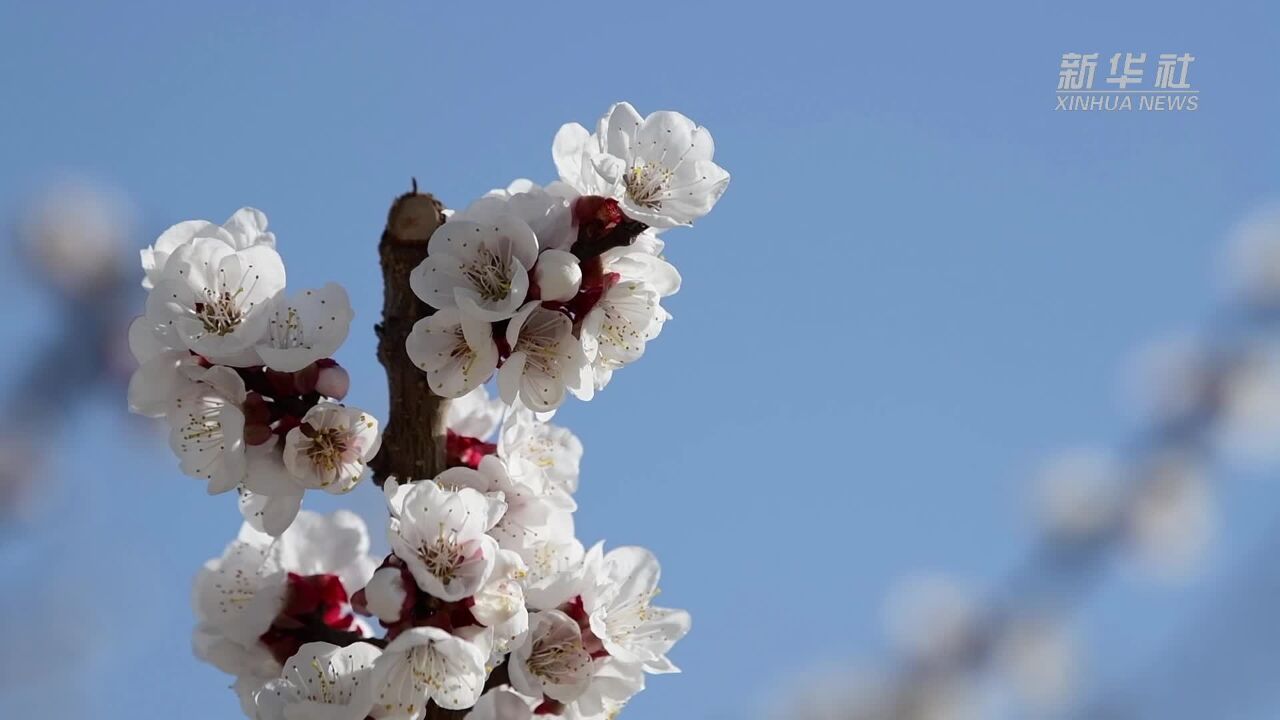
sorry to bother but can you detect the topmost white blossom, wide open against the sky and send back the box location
[552,102,728,228]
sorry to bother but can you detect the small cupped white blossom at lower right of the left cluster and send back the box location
[284,402,381,495]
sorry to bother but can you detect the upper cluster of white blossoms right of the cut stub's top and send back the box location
[406,102,728,411]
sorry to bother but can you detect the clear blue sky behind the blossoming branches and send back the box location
[0,0,1280,720]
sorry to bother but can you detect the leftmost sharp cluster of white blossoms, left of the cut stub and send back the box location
[129,208,379,536]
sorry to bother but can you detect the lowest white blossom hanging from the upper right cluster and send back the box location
[498,301,588,411]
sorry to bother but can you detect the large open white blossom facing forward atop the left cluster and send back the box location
[146,237,284,366]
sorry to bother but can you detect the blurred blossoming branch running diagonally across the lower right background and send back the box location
[780,202,1280,720]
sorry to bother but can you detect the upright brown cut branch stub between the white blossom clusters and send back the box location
[370,181,449,486]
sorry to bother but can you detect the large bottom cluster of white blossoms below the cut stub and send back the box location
[196,387,690,720]
